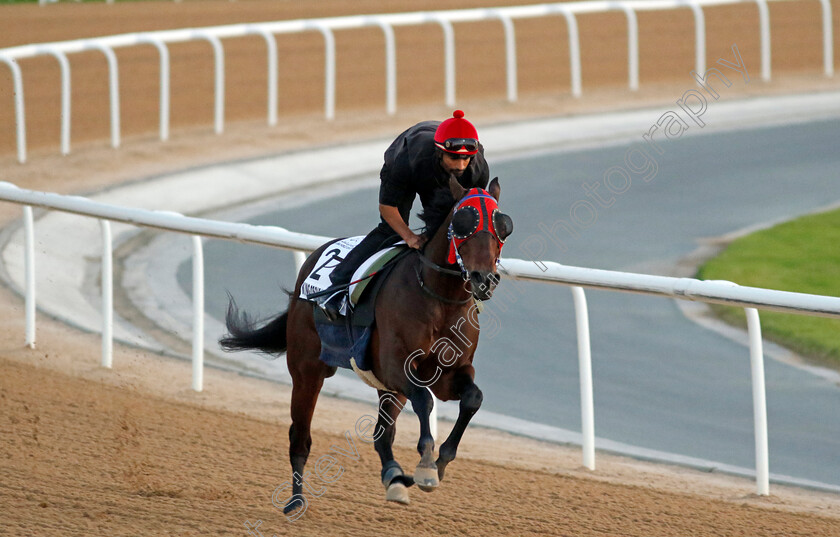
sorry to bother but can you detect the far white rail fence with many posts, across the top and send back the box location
[0,0,834,163]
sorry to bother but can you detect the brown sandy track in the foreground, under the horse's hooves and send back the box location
[0,353,840,537]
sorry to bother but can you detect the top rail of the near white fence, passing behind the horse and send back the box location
[0,183,840,318]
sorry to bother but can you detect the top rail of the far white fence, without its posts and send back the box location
[0,0,827,59]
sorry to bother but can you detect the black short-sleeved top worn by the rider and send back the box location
[379,121,490,223]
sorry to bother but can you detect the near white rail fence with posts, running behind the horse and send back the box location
[0,183,840,495]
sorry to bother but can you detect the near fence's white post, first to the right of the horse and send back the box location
[571,287,595,470]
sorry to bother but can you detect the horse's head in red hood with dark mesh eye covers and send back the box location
[447,177,513,300]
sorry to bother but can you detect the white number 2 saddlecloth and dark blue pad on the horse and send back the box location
[300,237,411,378]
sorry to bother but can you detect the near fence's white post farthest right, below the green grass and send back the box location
[744,308,770,496]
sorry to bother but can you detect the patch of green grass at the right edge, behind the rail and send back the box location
[697,210,840,367]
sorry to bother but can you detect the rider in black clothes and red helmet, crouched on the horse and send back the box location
[318,110,490,320]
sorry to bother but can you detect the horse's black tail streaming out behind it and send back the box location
[219,297,289,354]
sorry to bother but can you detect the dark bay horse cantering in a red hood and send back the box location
[220,176,513,514]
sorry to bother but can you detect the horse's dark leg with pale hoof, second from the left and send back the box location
[373,390,414,504]
